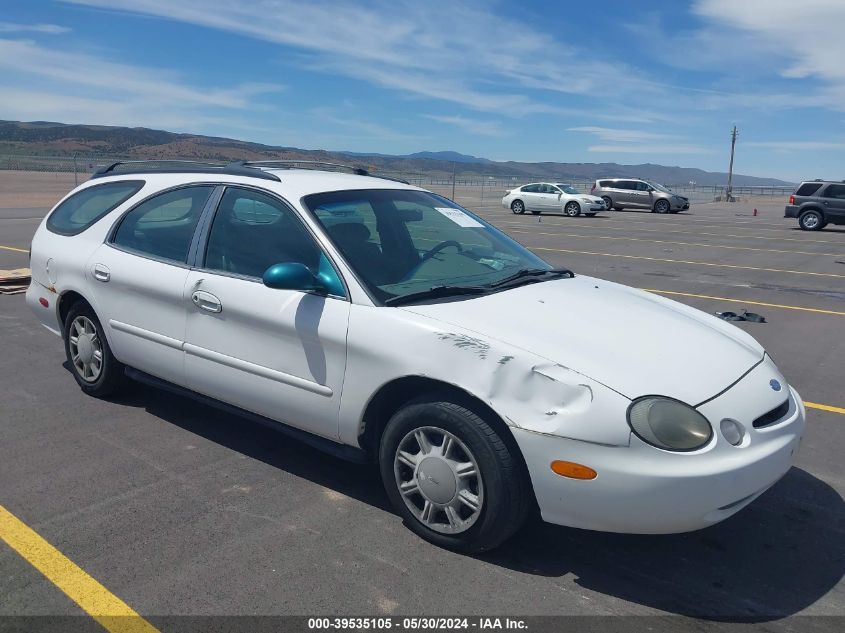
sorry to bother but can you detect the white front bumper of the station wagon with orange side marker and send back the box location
[513,361,805,534]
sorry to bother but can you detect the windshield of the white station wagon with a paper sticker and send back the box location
[303,189,551,302]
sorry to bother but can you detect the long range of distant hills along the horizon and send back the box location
[0,121,791,186]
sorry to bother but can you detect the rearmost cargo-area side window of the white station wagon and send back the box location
[47,180,144,235]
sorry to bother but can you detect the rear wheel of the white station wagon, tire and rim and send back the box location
[64,301,126,398]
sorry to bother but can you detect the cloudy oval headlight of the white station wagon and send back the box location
[628,396,713,451]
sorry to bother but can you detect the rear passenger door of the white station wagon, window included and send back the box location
[87,185,215,385]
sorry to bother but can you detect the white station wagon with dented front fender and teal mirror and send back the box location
[27,162,805,551]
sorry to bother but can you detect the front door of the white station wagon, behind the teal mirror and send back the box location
[182,187,350,439]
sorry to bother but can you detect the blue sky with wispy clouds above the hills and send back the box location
[0,0,845,180]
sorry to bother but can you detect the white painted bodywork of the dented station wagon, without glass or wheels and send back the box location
[27,170,804,533]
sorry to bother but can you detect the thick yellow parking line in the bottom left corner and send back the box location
[0,505,159,633]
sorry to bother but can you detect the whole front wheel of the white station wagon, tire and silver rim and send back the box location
[379,397,531,552]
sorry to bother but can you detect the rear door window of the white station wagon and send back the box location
[112,185,214,264]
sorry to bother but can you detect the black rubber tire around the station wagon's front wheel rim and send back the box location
[379,395,533,552]
